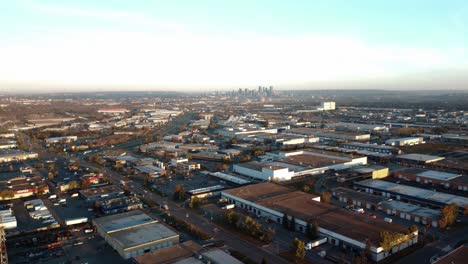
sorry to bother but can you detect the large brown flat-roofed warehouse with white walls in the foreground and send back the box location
[221,183,418,261]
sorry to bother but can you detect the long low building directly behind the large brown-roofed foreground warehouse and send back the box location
[332,187,441,227]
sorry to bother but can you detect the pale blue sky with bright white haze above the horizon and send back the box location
[0,0,468,92]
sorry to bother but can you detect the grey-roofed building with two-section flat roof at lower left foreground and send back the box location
[93,210,179,259]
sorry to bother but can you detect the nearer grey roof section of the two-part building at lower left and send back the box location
[110,223,178,249]
